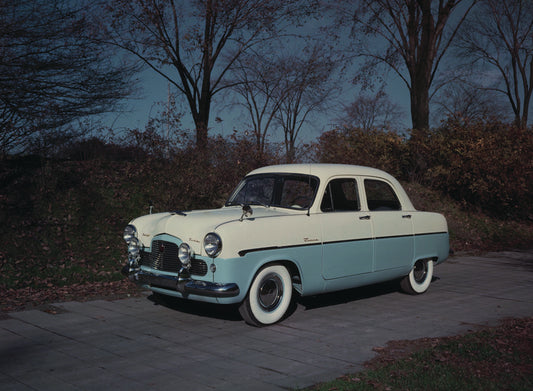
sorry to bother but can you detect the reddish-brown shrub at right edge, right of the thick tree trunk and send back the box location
[422,121,533,219]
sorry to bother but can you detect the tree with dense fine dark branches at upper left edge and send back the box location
[0,0,136,153]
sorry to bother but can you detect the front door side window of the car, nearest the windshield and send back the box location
[320,178,361,212]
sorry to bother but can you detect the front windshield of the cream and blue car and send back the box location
[226,174,318,209]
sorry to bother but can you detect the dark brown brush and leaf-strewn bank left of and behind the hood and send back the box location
[0,135,265,292]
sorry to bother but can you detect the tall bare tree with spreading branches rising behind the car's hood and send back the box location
[103,0,301,149]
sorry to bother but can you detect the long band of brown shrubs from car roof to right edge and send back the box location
[315,120,533,220]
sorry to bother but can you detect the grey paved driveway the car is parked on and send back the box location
[0,251,533,391]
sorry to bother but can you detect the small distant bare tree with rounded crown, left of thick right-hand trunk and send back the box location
[341,90,403,131]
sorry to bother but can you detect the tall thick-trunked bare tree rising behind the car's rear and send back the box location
[337,0,476,130]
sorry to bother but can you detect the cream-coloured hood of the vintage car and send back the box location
[130,205,296,252]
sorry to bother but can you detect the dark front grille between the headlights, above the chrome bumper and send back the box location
[141,240,207,276]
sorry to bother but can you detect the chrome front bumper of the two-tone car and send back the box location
[122,261,240,298]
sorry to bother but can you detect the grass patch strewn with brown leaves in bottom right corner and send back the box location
[358,317,533,390]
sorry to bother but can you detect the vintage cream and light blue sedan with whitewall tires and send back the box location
[123,164,449,326]
